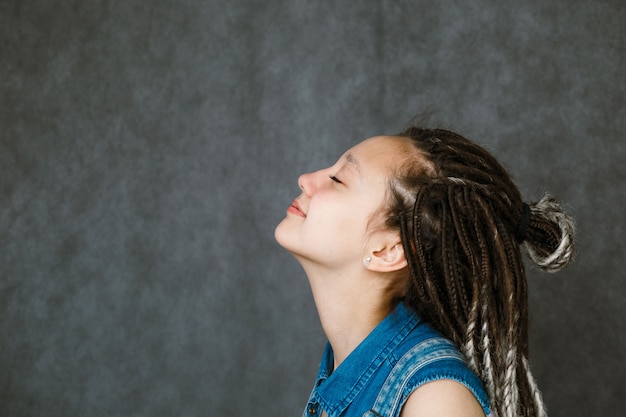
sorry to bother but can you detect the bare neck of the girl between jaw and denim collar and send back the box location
[303,263,392,368]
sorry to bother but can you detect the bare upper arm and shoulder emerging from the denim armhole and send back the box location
[400,379,485,417]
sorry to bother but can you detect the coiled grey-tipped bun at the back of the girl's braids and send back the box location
[522,194,575,272]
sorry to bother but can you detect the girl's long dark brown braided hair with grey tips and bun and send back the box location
[387,127,574,417]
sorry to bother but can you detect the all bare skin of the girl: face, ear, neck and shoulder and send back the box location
[275,136,484,417]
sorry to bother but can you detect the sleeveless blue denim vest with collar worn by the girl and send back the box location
[303,304,490,417]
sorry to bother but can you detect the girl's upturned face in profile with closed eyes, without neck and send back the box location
[275,136,410,267]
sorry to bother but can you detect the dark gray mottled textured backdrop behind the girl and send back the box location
[0,0,626,417]
